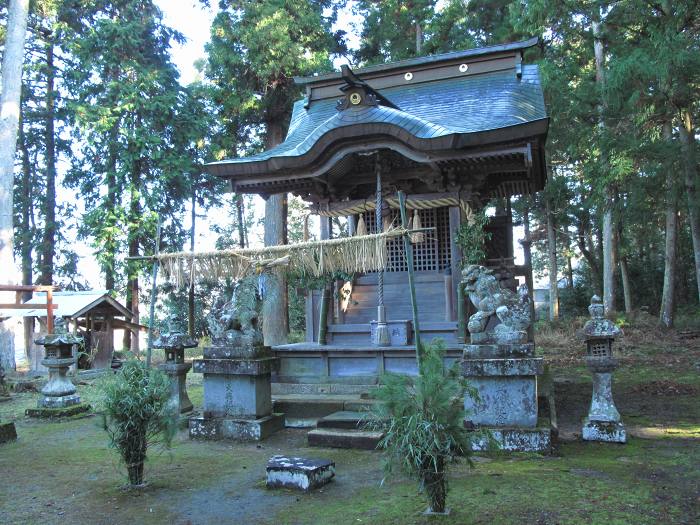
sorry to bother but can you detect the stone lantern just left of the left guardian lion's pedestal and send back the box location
[153,316,197,414]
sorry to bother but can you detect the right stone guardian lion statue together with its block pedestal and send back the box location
[461,265,551,452]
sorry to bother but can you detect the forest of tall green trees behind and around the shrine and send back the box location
[0,0,700,362]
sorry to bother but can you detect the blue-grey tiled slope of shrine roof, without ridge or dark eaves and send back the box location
[208,65,547,169]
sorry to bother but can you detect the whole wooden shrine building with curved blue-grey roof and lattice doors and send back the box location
[208,39,549,392]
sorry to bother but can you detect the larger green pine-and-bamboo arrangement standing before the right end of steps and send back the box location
[368,340,476,513]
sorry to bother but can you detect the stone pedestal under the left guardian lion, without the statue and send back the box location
[189,347,284,441]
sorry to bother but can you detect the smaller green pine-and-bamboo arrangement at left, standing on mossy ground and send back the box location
[102,359,177,487]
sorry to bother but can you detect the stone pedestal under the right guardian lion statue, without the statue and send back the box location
[462,343,551,452]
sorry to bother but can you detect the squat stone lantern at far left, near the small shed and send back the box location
[27,319,90,417]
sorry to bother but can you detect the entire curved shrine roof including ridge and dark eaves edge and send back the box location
[207,39,548,194]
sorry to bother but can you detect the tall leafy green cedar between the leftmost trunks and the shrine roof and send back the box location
[67,0,198,348]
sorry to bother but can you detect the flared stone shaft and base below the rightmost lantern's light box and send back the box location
[581,357,627,443]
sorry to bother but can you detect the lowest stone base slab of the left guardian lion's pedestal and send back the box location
[189,414,284,441]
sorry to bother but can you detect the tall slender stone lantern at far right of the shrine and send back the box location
[581,295,627,443]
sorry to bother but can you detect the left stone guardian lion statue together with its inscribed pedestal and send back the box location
[190,277,284,441]
